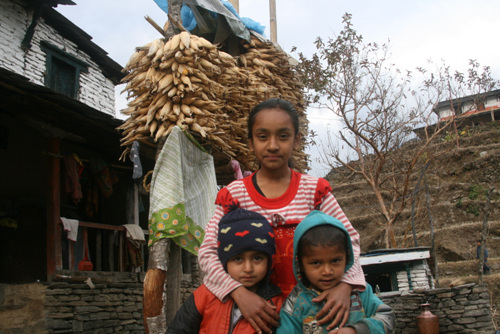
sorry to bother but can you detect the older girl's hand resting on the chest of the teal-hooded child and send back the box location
[312,282,352,330]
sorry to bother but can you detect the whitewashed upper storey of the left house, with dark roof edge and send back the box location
[0,0,122,116]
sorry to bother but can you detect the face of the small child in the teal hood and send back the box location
[300,245,347,292]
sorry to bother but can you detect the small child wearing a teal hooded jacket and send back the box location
[277,210,396,334]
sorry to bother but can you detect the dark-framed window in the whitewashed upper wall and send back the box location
[41,41,89,98]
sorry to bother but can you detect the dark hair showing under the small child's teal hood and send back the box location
[297,224,349,260]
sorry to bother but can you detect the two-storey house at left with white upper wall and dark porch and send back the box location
[0,0,154,333]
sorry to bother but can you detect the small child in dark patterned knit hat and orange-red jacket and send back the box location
[167,207,284,334]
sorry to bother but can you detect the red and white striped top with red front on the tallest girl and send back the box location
[198,170,366,300]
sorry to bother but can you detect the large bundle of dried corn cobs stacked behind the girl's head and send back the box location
[118,32,307,179]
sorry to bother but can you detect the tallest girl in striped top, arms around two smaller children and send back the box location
[198,98,366,333]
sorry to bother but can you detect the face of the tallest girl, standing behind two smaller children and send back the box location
[248,108,299,174]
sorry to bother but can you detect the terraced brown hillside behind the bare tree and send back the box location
[327,123,500,323]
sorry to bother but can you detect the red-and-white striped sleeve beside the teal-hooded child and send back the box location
[321,192,366,291]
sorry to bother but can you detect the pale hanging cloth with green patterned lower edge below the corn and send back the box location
[148,127,217,254]
